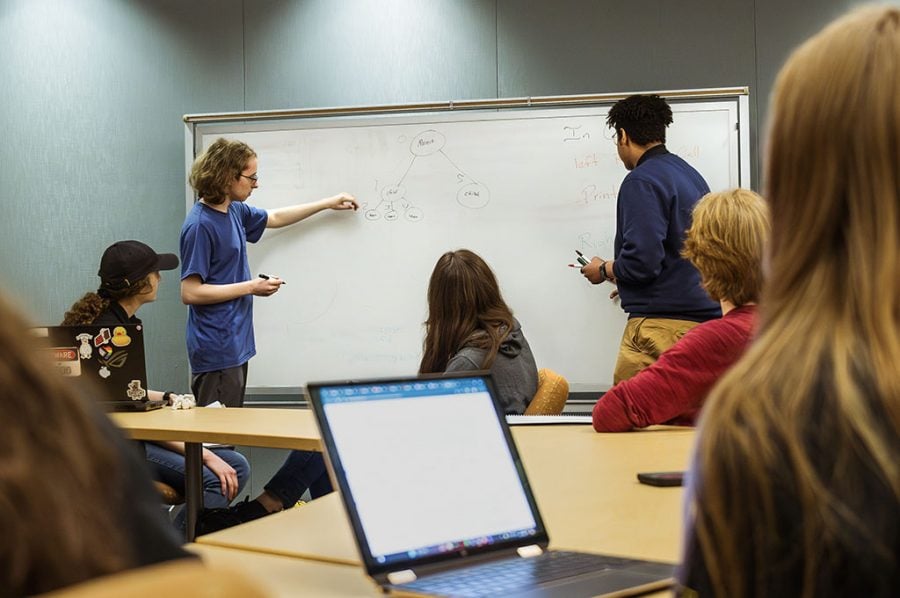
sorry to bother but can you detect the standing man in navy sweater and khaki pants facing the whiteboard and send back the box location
[581,95,722,384]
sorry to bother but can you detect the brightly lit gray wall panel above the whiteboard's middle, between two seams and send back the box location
[246,0,497,110]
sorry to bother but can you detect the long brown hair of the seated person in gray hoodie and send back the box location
[419,249,513,374]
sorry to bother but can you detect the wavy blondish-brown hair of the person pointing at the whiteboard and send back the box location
[188,137,256,205]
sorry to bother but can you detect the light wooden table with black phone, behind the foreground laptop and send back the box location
[197,425,694,566]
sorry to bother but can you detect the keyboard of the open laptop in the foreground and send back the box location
[395,551,638,597]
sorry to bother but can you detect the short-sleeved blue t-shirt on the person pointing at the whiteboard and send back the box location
[180,202,268,374]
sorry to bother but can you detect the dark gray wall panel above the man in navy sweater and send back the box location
[498,0,756,185]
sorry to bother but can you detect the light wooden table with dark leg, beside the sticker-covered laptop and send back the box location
[110,408,322,542]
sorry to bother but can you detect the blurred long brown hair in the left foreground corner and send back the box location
[0,298,132,596]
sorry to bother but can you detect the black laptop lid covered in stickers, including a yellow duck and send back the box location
[32,324,165,411]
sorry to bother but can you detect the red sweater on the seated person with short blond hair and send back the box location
[594,305,756,432]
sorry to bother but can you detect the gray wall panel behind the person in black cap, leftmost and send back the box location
[0,0,243,389]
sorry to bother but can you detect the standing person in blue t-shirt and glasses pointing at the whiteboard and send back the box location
[181,138,359,407]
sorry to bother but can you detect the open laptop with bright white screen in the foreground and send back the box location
[307,372,675,597]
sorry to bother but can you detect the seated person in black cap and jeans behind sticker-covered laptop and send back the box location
[62,241,250,528]
